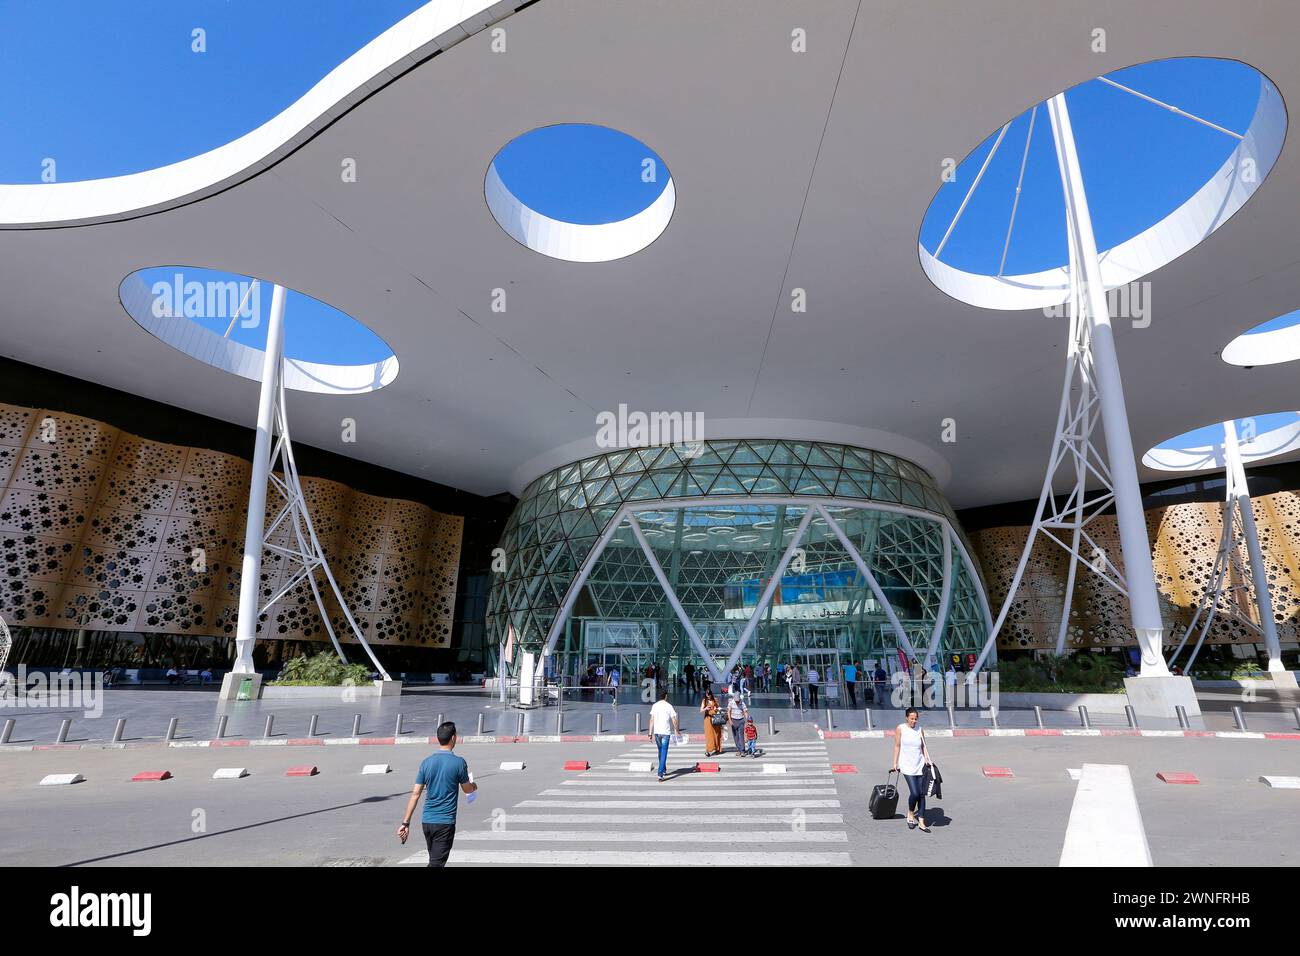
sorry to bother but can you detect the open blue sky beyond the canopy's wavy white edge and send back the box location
[0,0,424,183]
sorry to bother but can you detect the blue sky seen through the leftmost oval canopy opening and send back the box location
[135,265,393,365]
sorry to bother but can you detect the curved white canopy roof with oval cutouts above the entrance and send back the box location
[0,0,1300,507]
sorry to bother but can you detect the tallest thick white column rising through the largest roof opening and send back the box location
[1048,92,1169,678]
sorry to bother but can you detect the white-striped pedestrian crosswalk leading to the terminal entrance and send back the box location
[402,739,852,866]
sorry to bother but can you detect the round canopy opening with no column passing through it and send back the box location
[484,124,676,263]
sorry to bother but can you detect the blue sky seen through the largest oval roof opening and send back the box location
[920,57,1260,274]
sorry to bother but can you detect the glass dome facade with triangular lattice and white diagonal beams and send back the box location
[488,440,989,679]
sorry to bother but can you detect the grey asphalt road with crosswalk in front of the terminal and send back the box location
[0,727,1300,866]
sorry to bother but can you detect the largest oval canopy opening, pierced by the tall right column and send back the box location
[919,57,1287,310]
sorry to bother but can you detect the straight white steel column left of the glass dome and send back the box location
[231,285,286,674]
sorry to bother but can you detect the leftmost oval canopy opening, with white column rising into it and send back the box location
[117,265,398,394]
